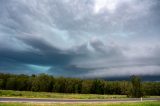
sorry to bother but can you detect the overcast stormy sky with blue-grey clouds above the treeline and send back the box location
[0,0,160,80]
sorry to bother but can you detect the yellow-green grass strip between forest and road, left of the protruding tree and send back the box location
[0,90,126,99]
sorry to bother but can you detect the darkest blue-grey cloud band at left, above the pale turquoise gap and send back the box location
[0,41,74,65]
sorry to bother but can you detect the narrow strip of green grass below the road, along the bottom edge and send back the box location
[0,101,160,106]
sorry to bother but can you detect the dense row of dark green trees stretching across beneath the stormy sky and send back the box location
[0,73,160,97]
